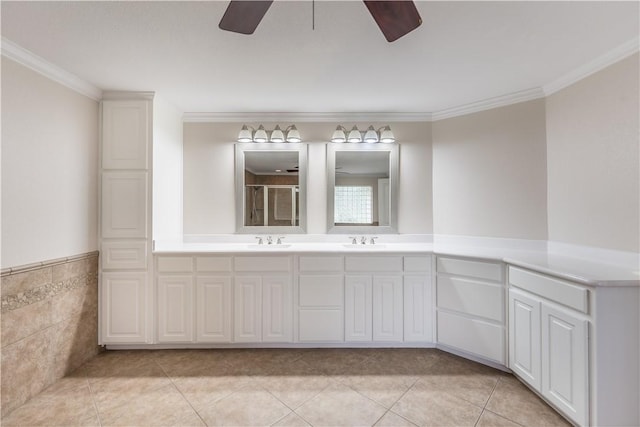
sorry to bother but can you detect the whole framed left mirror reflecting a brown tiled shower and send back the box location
[236,143,307,234]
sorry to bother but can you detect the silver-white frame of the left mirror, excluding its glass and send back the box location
[235,142,308,234]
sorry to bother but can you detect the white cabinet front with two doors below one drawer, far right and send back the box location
[509,267,591,425]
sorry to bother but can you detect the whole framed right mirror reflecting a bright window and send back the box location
[327,143,399,234]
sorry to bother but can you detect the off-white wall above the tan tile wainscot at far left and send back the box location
[1,57,98,268]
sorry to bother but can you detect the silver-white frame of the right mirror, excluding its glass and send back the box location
[327,143,400,235]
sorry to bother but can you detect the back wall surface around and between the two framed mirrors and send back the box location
[184,123,432,234]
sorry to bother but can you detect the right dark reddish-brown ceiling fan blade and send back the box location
[363,0,422,42]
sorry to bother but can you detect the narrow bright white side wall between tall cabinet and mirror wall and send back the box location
[153,95,182,239]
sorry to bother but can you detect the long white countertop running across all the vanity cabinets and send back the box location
[154,235,640,286]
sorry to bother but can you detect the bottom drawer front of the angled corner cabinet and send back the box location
[438,312,505,365]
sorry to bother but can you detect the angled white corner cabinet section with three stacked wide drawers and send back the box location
[436,256,506,365]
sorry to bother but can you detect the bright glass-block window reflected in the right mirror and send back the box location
[335,185,373,224]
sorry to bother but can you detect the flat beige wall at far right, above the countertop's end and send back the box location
[546,54,640,252]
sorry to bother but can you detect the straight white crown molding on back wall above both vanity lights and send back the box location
[182,113,431,123]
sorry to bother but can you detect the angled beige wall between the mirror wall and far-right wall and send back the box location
[433,99,547,239]
